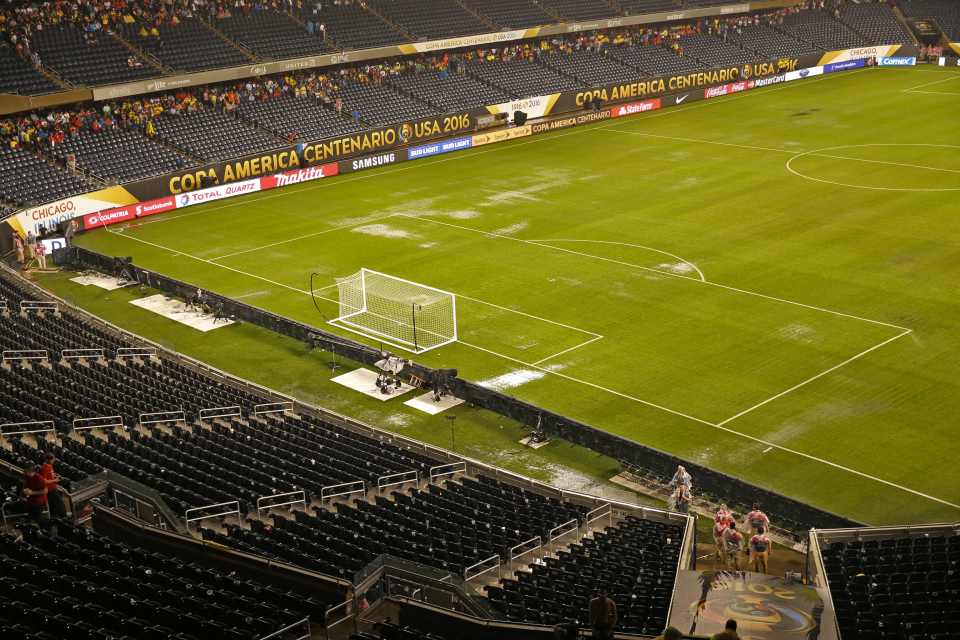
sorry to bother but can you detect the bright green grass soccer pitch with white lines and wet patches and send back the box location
[67,68,960,523]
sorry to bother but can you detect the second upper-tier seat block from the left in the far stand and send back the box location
[33,24,160,86]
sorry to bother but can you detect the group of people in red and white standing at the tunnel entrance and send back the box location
[713,503,773,573]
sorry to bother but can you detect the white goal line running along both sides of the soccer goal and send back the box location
[108,228,960,510]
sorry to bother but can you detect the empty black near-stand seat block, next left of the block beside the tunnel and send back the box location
[202,476,587,579]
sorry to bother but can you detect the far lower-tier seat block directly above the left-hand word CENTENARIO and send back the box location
[238,95,363,142]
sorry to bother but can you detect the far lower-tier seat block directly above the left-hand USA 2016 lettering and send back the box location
[389,71,512,112]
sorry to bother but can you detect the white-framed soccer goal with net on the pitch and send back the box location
[330,269,457,353]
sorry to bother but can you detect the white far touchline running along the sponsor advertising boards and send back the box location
[110,69,875,237]
